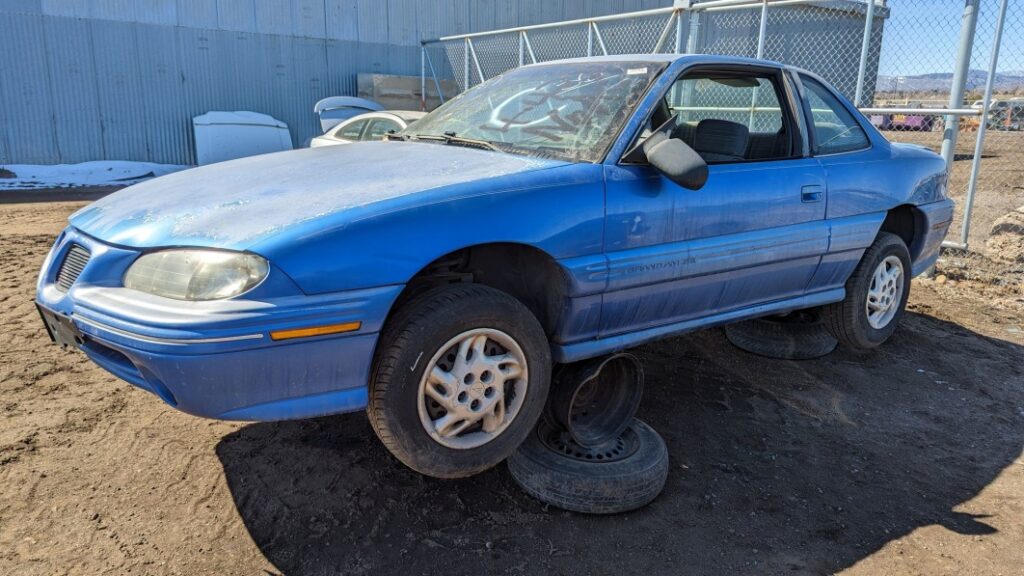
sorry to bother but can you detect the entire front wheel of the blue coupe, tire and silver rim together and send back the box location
[368,284,551,478]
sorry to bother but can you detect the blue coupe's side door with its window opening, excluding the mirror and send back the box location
[601,66,828,337]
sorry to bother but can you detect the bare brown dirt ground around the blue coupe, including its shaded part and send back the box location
[0,203,1024,575]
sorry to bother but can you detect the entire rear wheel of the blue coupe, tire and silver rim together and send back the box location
[823,232,910,349]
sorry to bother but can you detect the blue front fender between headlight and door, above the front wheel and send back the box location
[252,164,604,294]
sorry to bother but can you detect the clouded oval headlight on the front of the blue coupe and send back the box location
[125,250,269,300]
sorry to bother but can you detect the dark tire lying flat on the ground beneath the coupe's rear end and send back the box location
[725,311,838,360]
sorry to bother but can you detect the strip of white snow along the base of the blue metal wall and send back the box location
[0,160,191,191]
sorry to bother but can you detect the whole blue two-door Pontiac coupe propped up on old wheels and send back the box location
[37,55,952,478]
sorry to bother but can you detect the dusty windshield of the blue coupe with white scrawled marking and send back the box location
[401,61,664,162]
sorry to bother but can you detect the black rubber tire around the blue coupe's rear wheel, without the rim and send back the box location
[822,232,911,349]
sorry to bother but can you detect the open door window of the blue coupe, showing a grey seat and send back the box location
[666,71,793,164]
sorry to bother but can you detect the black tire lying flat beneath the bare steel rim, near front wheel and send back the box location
[508,418,669,515]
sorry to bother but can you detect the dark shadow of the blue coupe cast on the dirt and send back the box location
[211,314,1024,575]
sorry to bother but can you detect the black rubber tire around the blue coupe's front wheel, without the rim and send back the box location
[367,284,551,478]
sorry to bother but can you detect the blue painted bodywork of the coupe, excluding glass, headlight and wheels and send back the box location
[37,55,952,420]
